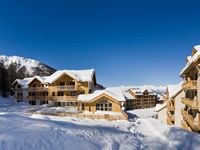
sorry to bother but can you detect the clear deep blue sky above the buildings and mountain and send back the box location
[0,0,200,86]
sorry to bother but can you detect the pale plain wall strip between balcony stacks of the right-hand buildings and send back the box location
[174,91,185,127]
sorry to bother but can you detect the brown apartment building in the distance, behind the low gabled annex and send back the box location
[123,87,159,110]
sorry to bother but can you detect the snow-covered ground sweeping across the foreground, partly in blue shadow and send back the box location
[0,97,200,150]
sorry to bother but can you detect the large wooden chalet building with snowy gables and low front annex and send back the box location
[12,69,125,115]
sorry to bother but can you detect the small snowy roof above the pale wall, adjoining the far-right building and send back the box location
[167,82,183,98]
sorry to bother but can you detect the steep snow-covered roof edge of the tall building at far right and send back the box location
[180,45,200,76]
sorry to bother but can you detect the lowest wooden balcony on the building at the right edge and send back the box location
[181,110,200,132]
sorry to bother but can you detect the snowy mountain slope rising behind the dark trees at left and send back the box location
[0,55,55,75]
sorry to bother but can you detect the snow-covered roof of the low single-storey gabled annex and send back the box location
[78,87,126,102]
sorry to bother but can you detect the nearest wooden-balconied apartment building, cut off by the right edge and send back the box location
[180,45,200,133]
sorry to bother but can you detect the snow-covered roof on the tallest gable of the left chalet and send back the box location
[45,69,95,83]
